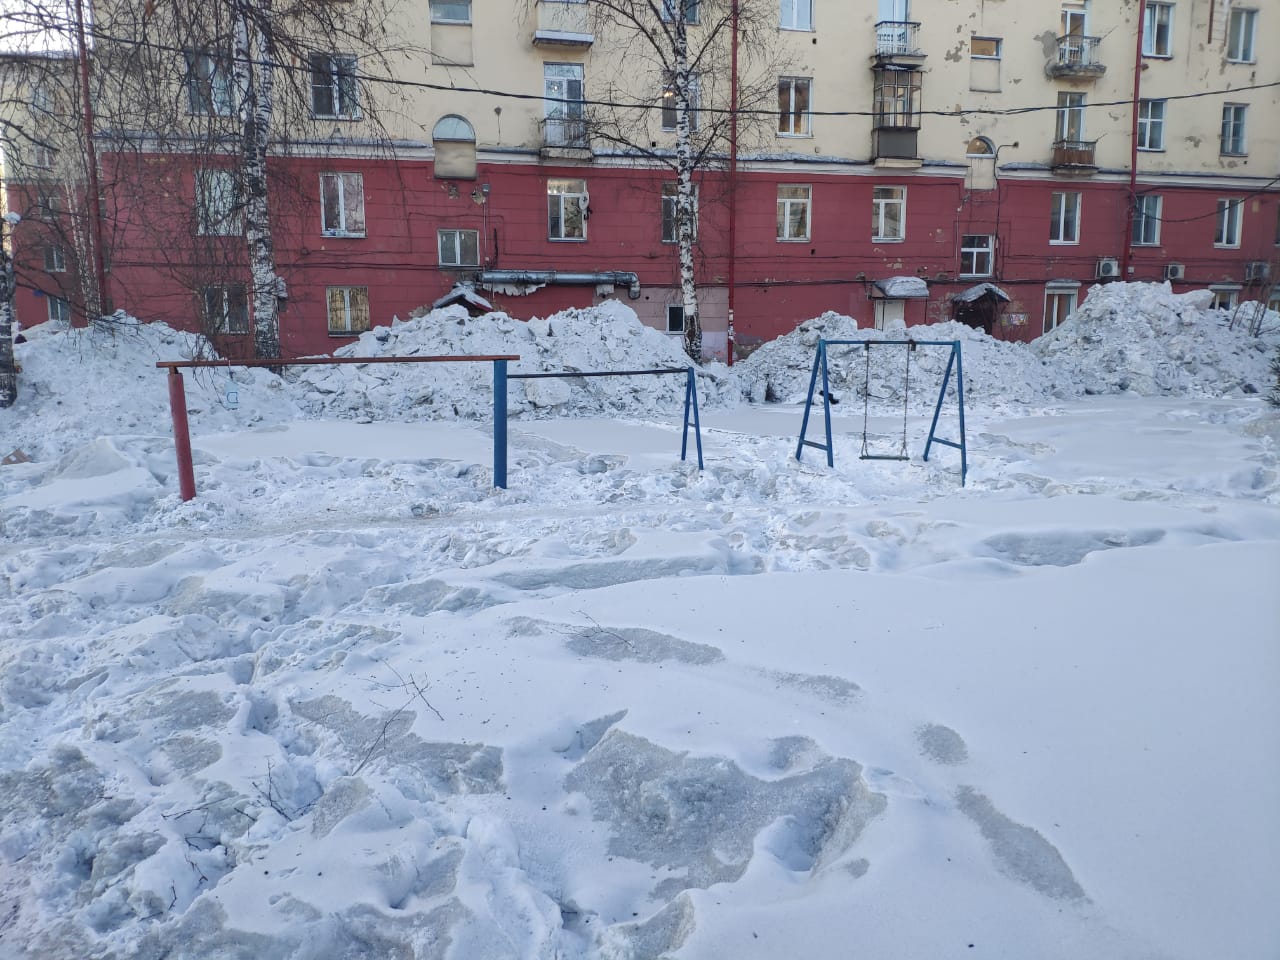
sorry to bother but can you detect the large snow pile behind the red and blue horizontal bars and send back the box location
[287,301,730,420]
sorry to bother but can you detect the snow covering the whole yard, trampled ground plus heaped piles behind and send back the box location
[0,284,1280,960]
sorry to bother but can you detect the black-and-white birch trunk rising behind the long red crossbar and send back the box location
[233,0,282,358]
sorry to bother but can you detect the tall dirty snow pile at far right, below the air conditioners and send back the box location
[1033,283,1280,397]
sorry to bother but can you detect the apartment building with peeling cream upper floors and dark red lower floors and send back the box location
[8,0,1280,357]
